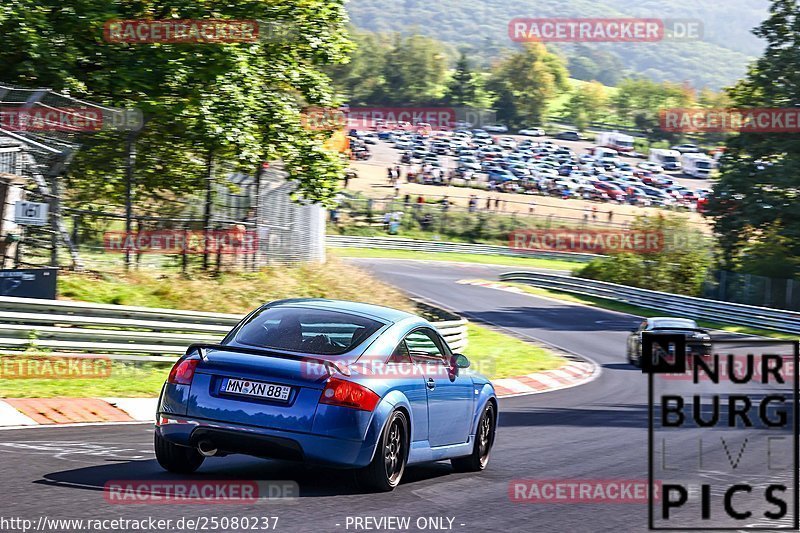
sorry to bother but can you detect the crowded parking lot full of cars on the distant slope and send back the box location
[348,131,711,228]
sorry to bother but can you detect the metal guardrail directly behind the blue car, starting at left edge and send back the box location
[0,296,467,360]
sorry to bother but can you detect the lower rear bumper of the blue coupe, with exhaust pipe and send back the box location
[156,413,375,468]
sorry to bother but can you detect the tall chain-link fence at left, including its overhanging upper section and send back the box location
[0,85,325,270]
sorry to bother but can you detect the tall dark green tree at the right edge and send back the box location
[709,0,800,276]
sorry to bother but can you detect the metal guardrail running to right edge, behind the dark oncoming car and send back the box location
[500,272,800,334]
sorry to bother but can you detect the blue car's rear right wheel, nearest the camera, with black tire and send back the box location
[357,411,410,492]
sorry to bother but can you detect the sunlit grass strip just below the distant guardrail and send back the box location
[328,248,585,271]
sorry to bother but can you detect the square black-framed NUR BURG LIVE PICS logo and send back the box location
[640,331,800,531]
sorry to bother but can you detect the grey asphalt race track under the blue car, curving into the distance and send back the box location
[0,259,788,532]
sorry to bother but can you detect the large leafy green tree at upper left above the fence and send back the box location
[0,0,349,205]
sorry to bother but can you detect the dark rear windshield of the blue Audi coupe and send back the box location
[234,307,383,355]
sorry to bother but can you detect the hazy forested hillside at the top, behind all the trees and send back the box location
[348,0,768,89]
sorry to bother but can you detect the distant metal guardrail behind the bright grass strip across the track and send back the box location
[325,235,604,263]
